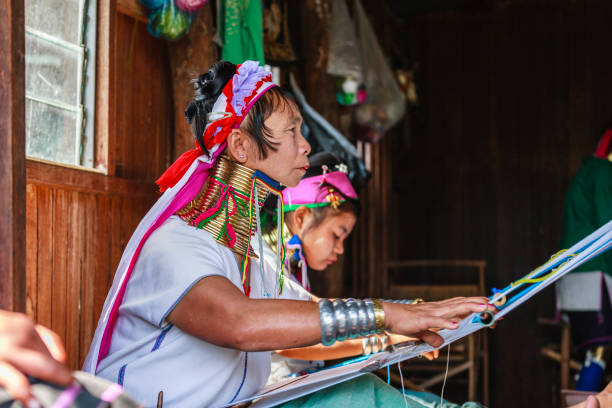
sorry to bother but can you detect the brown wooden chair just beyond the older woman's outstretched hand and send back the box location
[383,259,489,405]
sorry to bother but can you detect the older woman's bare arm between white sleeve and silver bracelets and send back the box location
[168,276,321,351]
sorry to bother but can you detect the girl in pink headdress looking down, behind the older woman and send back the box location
[263,152,437,374]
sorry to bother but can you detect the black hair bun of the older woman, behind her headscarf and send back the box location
[185,61,236,151]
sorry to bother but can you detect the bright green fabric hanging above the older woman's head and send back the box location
[219,0,265,65]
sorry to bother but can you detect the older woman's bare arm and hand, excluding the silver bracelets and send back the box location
[168,276,493,351]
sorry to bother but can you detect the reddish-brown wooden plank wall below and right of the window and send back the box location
[25,14,173,368]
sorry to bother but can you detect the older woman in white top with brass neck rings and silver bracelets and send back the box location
[84,61,491,407]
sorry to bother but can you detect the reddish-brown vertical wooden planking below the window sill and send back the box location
[26,178,156,368]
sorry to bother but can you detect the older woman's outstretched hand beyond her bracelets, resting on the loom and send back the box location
[383,297,496,347]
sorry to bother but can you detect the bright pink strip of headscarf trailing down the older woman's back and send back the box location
[96,155,223,369]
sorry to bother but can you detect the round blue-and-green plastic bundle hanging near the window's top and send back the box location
[147,0,194,41]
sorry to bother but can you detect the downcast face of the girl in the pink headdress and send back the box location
[298,211,357,271]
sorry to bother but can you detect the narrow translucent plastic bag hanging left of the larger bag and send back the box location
[327,0,362,82]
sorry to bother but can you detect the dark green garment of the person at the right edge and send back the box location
[561,157,612,276]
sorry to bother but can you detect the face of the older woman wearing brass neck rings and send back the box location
[249,102,310,187]
